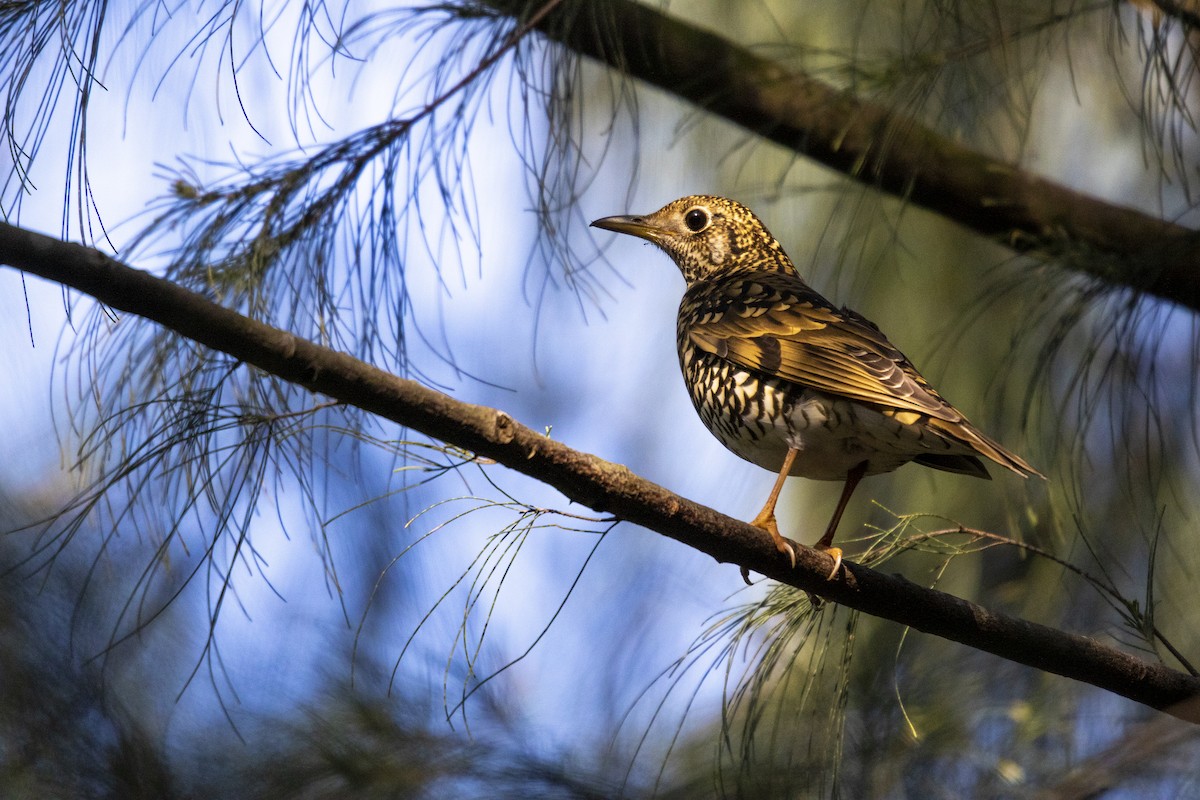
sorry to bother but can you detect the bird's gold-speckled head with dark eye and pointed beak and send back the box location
[592,194,796,285]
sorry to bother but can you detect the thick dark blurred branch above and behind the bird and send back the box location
[499,0,1200,311]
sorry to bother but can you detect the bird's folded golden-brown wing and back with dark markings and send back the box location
[684,273,962,422]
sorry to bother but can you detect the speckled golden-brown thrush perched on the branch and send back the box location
[592,194,1044,583]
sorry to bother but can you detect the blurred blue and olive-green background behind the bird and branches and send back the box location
[0,0,1200,798]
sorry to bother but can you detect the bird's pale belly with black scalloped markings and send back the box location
[685,363,960,481]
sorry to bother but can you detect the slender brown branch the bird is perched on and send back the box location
[0,223,1200,722]
